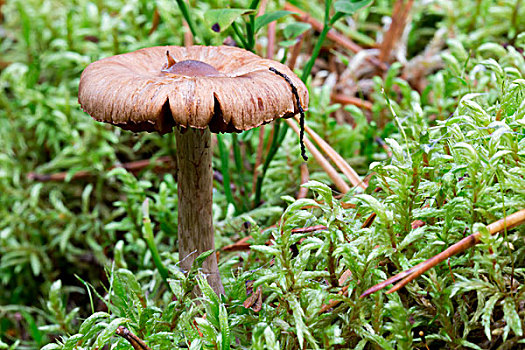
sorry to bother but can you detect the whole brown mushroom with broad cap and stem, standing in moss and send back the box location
[78,46,308,293]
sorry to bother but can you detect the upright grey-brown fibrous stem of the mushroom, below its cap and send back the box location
[175,128,224,294]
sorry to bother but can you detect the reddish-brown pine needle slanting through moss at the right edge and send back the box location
[360,209,525,298]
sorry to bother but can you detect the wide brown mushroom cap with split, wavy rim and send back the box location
[78,46,308,133]
